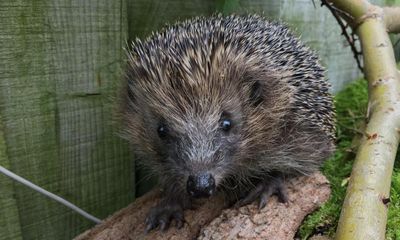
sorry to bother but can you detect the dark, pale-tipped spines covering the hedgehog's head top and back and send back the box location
[130,15,335,139]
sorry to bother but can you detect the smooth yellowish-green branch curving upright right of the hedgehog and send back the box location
[329,0,400,240]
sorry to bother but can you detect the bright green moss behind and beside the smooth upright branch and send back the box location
[299,79,400,239]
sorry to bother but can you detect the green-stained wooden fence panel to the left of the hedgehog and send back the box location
[0,0,134,239]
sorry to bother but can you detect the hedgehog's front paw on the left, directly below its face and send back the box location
[145,201,184,233]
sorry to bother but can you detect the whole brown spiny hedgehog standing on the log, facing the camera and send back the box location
[119,15,335,231]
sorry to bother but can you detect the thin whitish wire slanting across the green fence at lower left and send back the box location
[0,166,101,223]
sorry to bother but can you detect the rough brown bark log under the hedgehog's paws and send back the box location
[75,173,330,240]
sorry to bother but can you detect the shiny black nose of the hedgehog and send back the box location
[187,173,215,198]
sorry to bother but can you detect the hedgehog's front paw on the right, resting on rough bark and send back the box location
[235,177,288,209]
